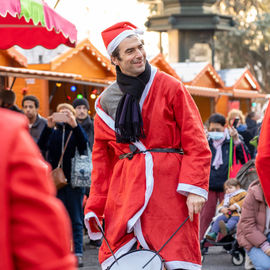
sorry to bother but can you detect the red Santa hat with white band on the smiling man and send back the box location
[101,22,143,56]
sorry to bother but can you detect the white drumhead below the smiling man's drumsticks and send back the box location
[109,249,164,270]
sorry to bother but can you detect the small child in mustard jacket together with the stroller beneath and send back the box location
[201,178,246,265]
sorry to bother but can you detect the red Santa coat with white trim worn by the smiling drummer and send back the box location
[85,67,211,269]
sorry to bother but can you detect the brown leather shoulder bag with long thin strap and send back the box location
[51,131,72,190]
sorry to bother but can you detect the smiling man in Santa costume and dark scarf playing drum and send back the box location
[85,22,211,269]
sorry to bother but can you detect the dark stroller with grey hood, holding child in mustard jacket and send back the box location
[201,159,258,266]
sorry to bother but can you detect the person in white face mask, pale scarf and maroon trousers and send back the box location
[200,113,248,240]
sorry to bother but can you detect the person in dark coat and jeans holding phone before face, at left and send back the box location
[38,103,88,267]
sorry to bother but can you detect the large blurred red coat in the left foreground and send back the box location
[0,109,76,270]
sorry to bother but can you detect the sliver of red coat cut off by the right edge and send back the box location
[256,105,270,205]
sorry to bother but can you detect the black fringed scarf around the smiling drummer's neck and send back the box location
[115,61,151,143]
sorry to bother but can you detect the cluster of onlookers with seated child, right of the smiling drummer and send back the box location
[200,109,270,270]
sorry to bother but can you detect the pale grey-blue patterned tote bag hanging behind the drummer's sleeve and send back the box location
[70,143,93,188]
